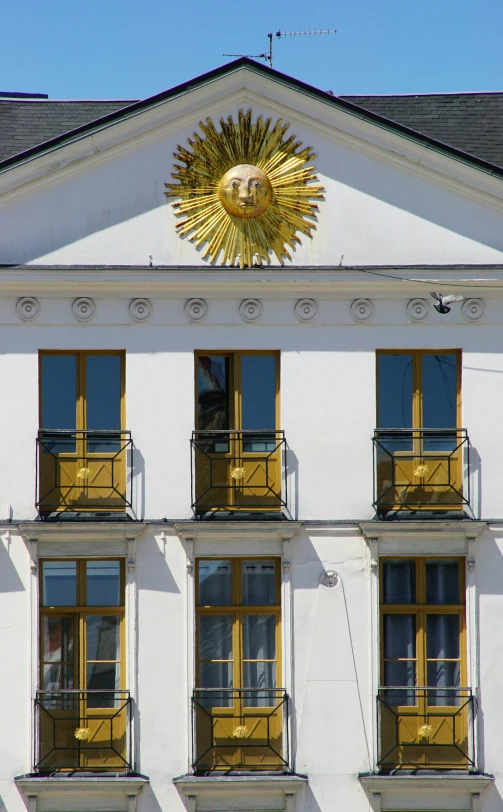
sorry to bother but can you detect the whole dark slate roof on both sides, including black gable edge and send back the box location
[0,57,503,177]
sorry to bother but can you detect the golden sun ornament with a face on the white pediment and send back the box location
[165,110,325,268]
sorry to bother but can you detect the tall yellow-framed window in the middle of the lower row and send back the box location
[194,558,286,770]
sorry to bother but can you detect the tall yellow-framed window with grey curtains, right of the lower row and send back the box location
[379,558,472,768]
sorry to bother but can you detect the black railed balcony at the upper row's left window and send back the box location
[35,429,133,515]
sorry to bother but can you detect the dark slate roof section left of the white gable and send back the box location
[0,96,136,161]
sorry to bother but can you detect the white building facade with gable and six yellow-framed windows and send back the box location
[0,60,503,812]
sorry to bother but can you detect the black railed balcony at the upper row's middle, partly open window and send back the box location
[191,429,287,517]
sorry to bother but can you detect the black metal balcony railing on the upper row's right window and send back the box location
[373,429,470,512]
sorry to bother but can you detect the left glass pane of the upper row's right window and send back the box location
[377,353,412,432]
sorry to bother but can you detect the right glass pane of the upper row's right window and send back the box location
[422,353,458,429]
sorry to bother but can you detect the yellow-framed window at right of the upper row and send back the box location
[374,350,468,510]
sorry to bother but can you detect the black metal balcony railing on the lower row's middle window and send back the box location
[192,688,291,773]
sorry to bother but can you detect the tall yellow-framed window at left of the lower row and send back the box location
[37,558,128,769]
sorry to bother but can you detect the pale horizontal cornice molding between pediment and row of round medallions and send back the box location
[0,264,503,298]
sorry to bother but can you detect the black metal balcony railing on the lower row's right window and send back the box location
[377,686,475,772]
